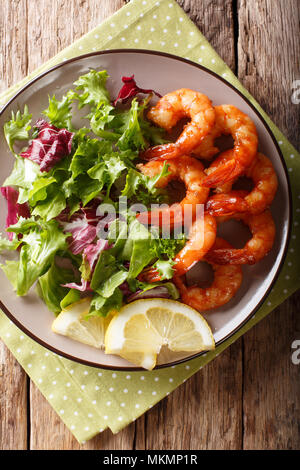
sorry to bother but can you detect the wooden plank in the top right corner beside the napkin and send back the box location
[238,0,300,148]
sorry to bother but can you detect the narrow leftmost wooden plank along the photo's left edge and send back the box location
[0,0,27,450]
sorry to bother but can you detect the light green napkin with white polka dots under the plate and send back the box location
[0,0,300,442]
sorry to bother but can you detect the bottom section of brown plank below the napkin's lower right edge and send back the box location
[136,340,242,450]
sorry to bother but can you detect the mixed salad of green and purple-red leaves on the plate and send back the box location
[0,70,185,316]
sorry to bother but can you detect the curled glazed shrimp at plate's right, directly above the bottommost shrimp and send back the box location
[206,209,275,265]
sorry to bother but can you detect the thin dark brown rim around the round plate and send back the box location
[0,48,293,372]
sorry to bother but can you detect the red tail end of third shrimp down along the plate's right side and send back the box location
[205,191,249,217]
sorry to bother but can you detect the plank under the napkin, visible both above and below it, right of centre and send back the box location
[136,0,242,449]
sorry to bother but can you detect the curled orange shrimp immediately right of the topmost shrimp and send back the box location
[193,105,258,187]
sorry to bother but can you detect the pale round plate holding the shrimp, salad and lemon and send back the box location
[0,50,291,370]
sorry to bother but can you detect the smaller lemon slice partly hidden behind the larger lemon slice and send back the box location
[52,298,111,349]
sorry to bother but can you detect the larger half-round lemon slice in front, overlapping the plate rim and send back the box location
[105,299,215,369]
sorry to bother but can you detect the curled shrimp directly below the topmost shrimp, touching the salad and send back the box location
[137,155,209,227]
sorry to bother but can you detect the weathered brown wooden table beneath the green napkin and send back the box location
[0,0,300,450]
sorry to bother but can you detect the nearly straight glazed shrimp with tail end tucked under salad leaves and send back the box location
[138,214,217,282]
